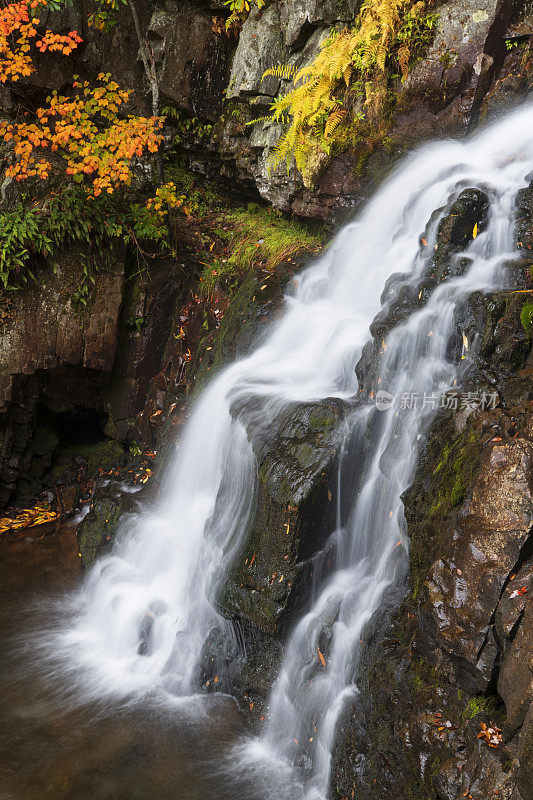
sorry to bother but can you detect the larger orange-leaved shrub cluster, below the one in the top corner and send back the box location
[0,73,163,197]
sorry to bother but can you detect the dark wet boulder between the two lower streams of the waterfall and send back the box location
[219,399,347,634]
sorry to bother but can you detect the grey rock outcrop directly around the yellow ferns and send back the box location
[218,0,525,218]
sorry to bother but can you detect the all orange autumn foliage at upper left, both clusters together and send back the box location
[0,0,163,197]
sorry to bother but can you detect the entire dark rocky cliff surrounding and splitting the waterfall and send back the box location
[0,0,533,800]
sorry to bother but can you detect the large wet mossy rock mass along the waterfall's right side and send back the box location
[332,189,533,800]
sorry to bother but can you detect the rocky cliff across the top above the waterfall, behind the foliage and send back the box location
[5,0,533,218]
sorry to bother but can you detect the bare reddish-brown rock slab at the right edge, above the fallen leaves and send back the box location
[421,439,533,691]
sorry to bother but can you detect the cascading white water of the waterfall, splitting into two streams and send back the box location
[55,108,533,800]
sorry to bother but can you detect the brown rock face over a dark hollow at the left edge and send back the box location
[0,249,124,505]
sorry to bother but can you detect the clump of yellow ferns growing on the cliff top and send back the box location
[252,0,435,185]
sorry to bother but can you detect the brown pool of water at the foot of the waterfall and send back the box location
[0,528,292,800]
